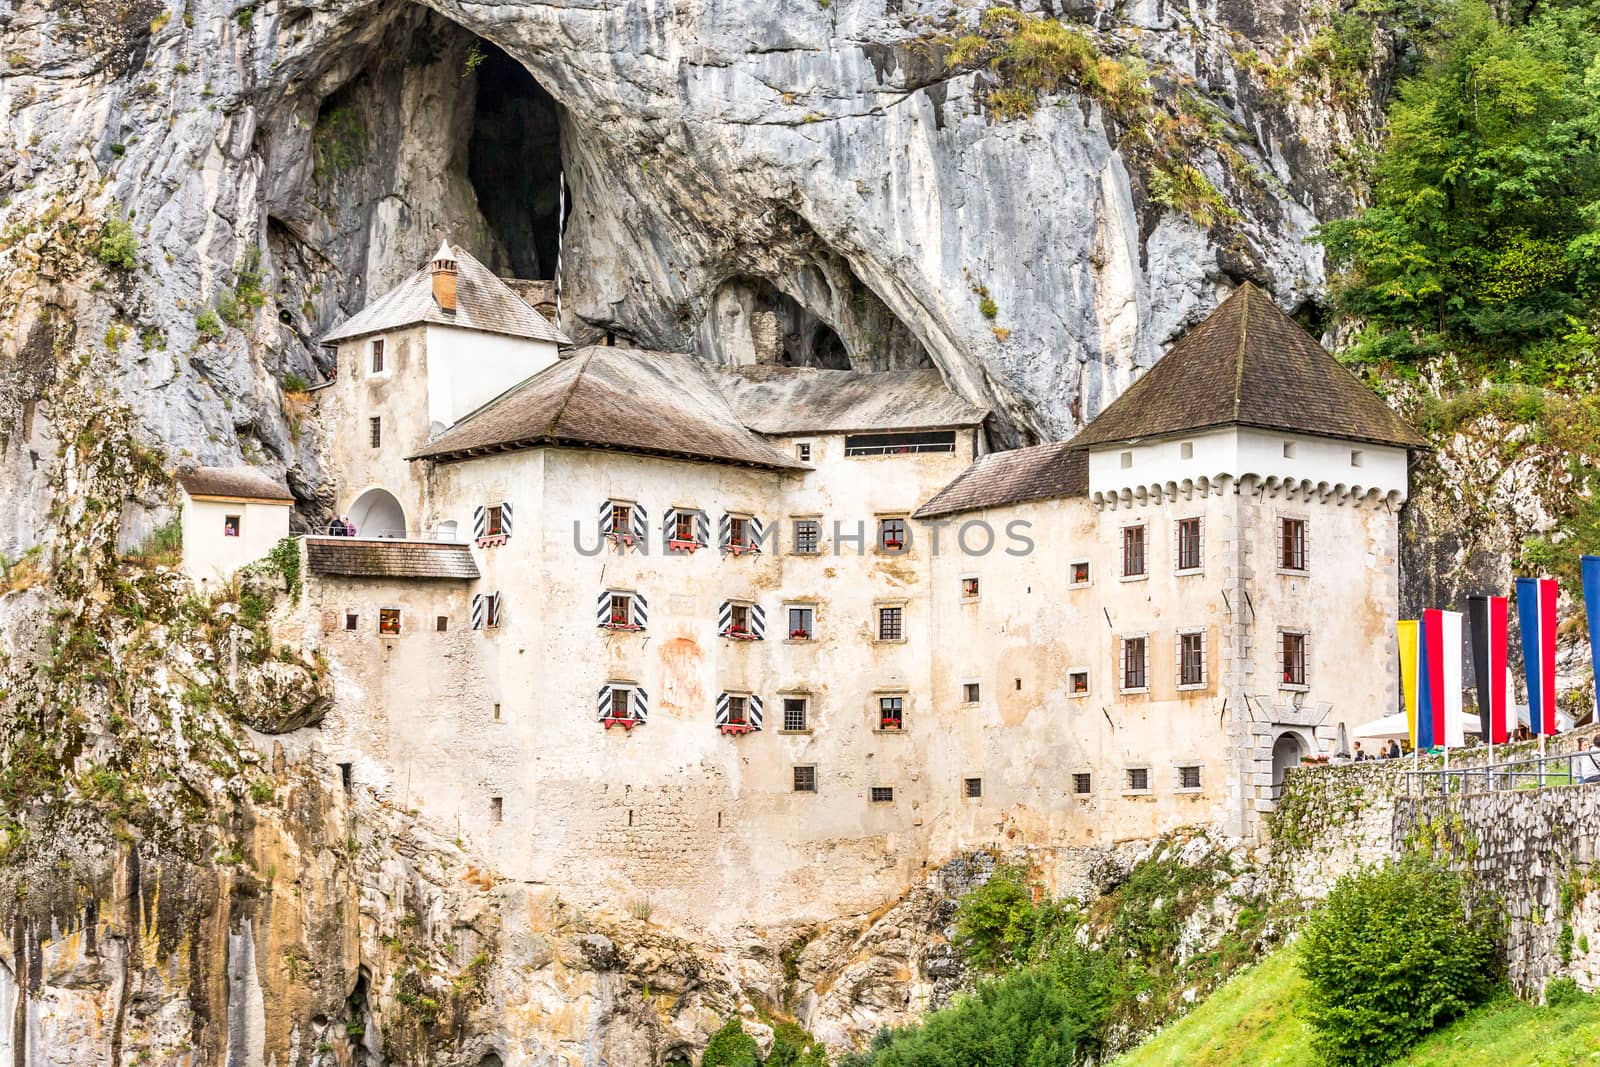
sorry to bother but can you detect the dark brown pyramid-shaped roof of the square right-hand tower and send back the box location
[1072,282,1427,448]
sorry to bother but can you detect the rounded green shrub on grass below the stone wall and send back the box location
[1301,857,1499,1067]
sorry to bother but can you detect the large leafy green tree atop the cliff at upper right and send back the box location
[1318,0,1600,369]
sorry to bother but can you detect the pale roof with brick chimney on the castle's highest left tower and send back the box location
[322,248,568,344]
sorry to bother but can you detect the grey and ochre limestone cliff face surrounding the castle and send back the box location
[0,0,1387,1065]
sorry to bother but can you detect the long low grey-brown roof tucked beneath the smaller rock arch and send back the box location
[720,366,989,435]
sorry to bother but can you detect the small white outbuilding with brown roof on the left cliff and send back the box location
[178,467,294,582]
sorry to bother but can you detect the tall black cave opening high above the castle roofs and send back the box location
[467,40,562,280]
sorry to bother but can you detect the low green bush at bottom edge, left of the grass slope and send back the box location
[840,971,1098,1067]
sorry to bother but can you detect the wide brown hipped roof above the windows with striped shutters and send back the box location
[410,347,805,469]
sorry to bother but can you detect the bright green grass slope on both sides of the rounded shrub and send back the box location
[1112,947,1600,1067]
